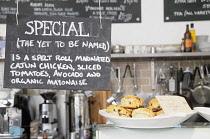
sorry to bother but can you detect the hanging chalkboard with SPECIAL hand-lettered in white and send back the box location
[4,15,111,90]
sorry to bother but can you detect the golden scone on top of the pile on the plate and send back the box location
[120,95,144,108]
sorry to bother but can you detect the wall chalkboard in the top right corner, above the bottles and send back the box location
[164,0,210,22]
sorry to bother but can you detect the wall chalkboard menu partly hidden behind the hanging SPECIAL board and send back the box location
[0,0,141,23]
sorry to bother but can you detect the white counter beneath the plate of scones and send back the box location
[96,122,210,139]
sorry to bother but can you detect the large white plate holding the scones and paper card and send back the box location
[99,109,196,128]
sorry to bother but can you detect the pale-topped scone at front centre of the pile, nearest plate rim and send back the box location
[132,108,155,118]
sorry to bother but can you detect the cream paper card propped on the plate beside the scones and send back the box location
[156,96,192,114]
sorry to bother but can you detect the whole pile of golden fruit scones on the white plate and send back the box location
[106,95,164,118]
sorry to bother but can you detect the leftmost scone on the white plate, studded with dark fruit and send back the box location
[106,105,131,117]
